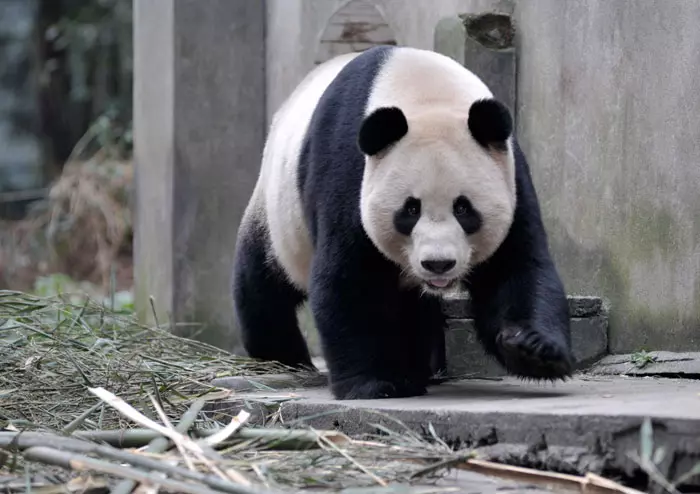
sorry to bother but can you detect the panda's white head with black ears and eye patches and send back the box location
[358,99,515,295]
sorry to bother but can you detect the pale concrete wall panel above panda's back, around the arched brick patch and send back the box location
[267,0,511,122]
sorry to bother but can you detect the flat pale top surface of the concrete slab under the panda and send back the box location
[270,376,700,421]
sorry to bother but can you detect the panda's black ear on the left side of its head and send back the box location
[357,106,408,156]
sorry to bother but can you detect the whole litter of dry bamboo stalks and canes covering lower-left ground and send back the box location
[0,291,470,492]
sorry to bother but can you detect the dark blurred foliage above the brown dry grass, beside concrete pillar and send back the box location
[37,0,133,172]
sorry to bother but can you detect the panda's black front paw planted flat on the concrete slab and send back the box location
[331,376,426,400]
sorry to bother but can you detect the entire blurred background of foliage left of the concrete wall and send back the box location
[0,0,133,307]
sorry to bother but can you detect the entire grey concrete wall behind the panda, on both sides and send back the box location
[135,0,700,352]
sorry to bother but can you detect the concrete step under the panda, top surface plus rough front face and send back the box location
[215,374,700,492]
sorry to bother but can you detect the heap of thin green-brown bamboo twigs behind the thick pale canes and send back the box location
[0,291,292,430]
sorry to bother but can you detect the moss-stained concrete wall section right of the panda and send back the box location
[516,0,700,352]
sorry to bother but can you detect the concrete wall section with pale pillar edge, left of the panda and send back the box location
[134,0,266,349]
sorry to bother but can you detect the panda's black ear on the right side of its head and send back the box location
[468,98,513,150]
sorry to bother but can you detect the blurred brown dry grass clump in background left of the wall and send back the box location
[0,113,134,292]
